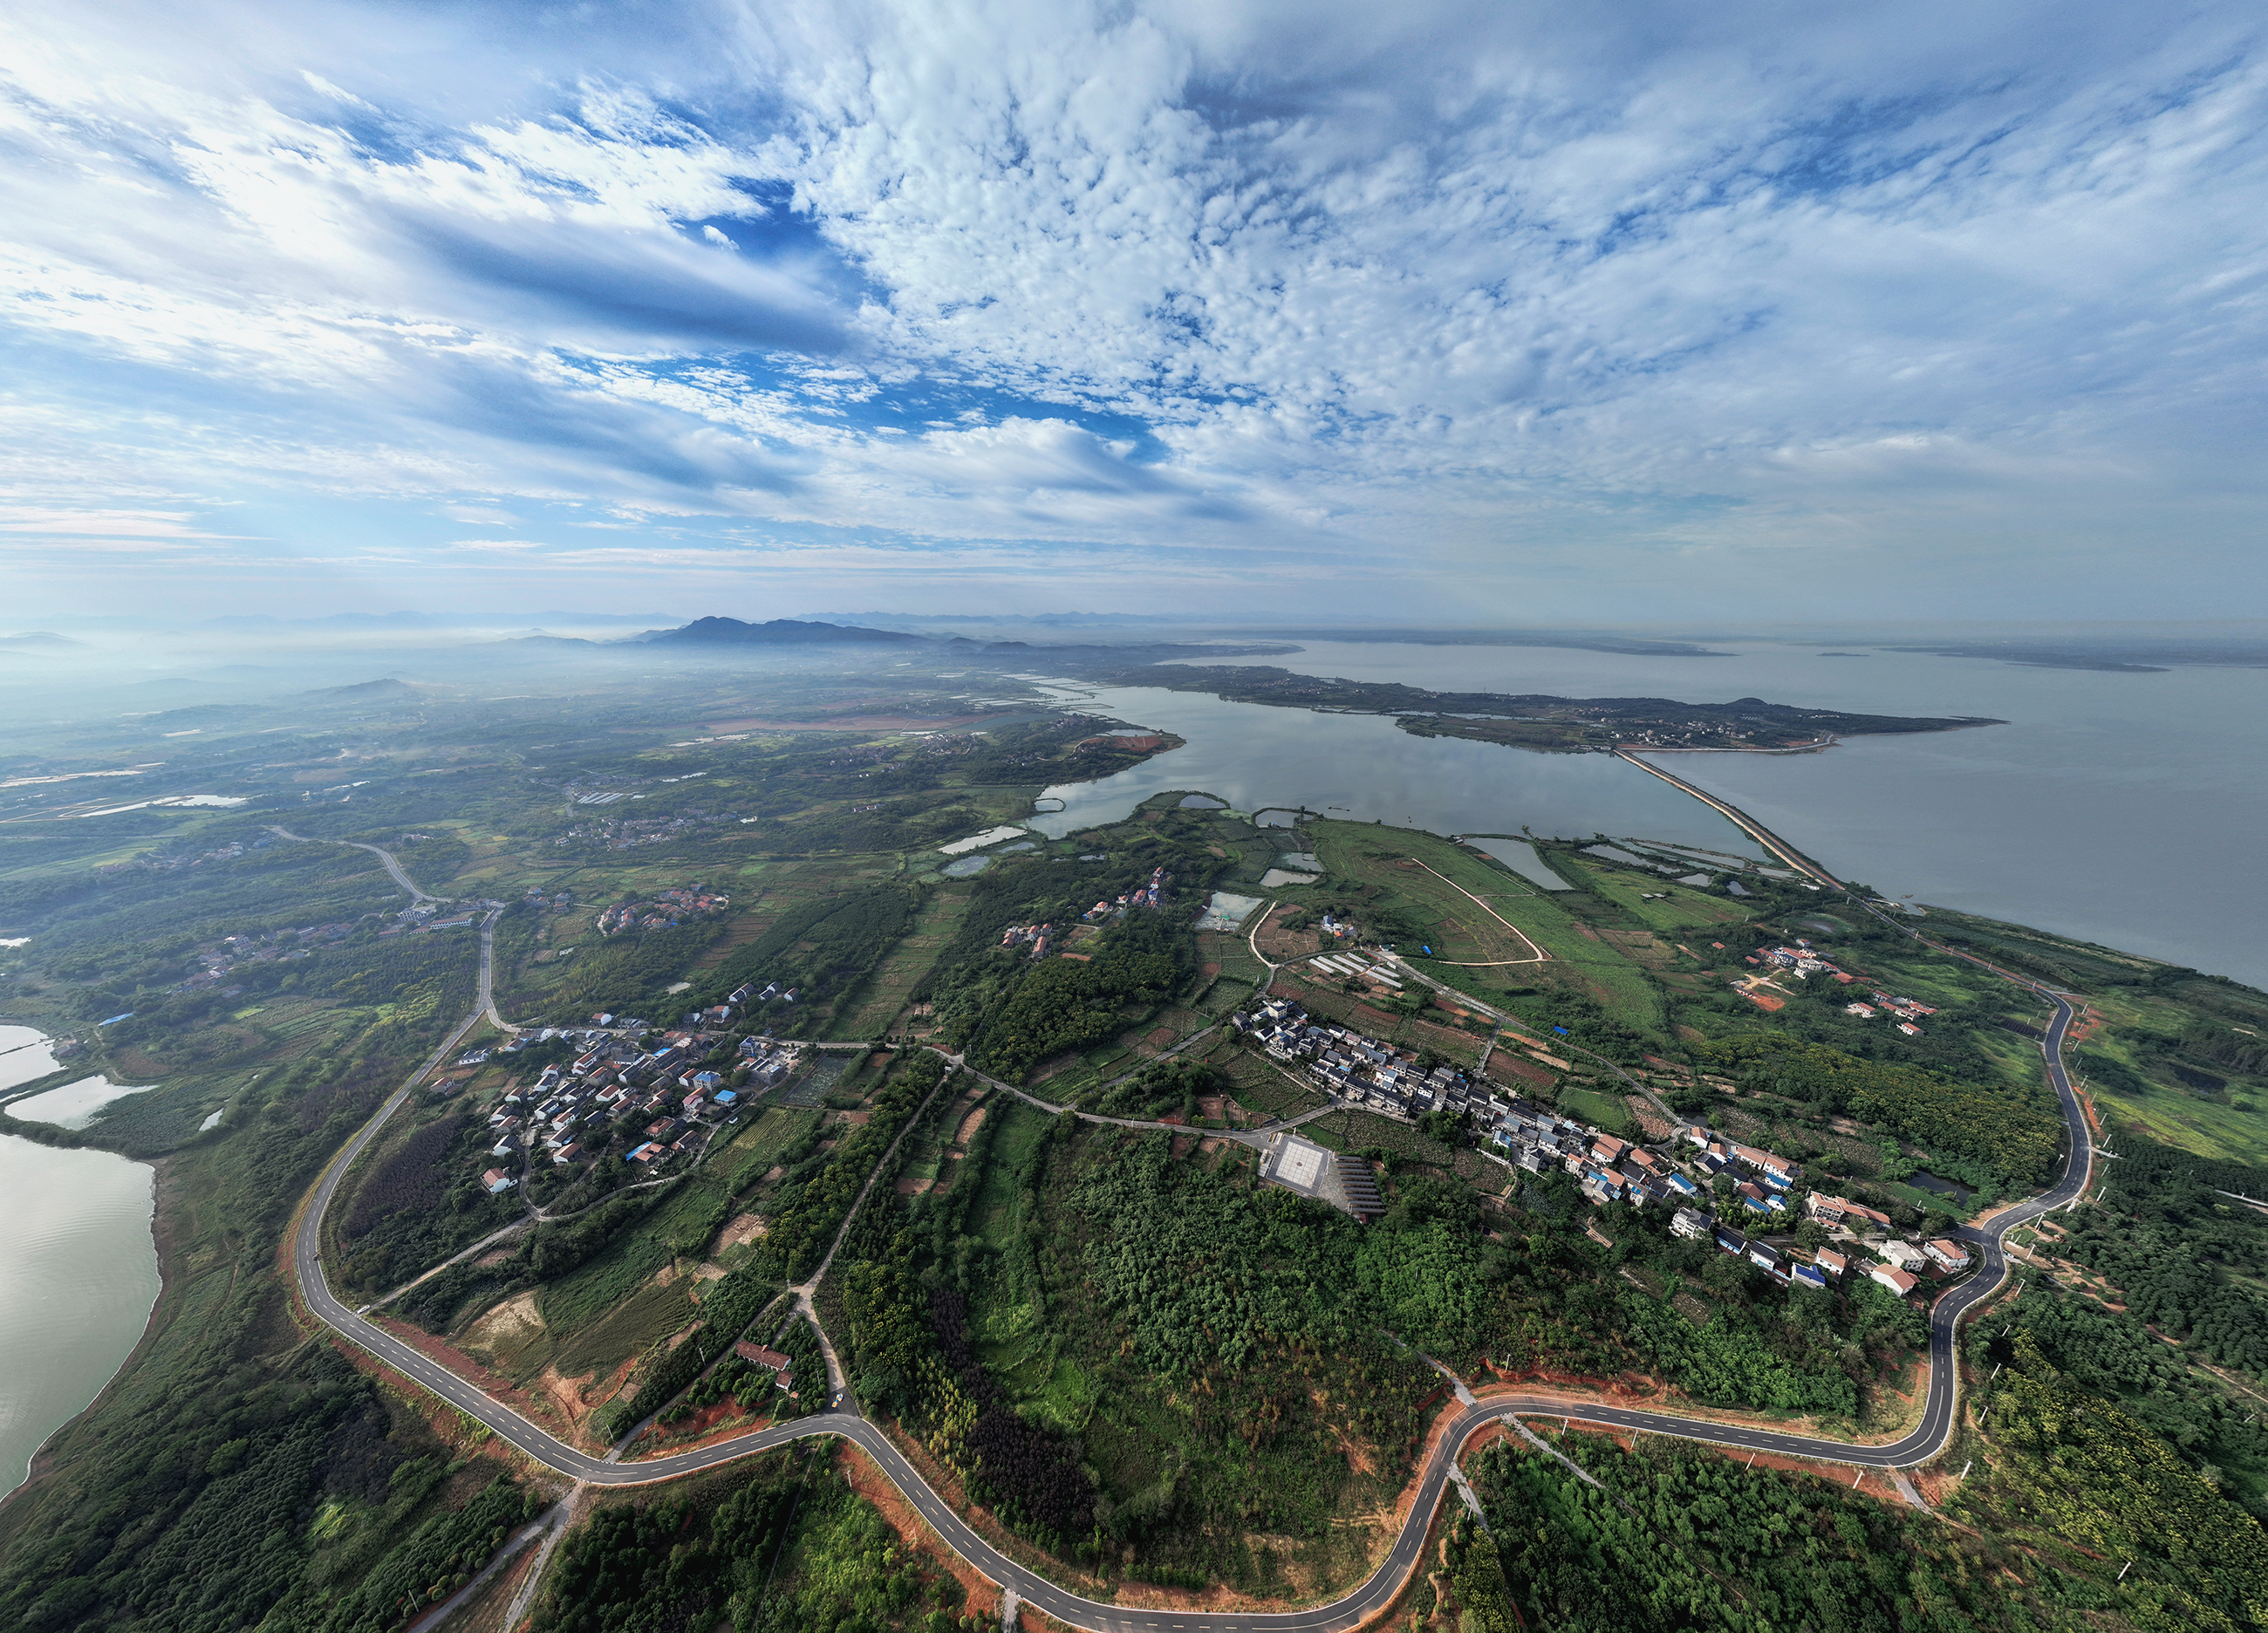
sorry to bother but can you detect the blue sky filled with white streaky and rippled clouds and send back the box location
[0,0,2268,624]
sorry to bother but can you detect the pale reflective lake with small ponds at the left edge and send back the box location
[0,1025,156,1494]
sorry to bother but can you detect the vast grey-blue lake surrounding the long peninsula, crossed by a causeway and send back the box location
[1111,642,2268,987]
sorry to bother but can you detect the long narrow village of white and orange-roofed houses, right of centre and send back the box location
[1233,988,1973,1297]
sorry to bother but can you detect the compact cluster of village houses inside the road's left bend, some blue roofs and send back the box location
[481,1032,794,1193]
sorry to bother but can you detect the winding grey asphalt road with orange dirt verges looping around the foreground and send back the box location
[290,844,2094,1633]
